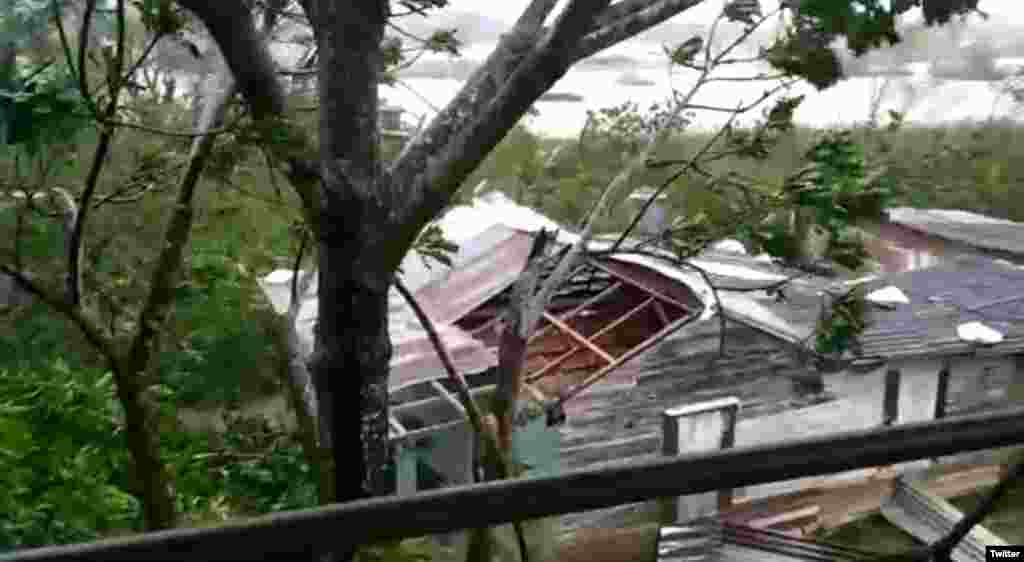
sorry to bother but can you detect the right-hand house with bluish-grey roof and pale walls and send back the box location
[856,255,1024,438]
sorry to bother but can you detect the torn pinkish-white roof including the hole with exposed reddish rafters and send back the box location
[261,192,806,397]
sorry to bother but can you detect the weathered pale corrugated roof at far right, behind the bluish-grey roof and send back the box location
[888,207,1024,254]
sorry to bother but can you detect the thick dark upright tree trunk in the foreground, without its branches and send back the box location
[311,0,393,502]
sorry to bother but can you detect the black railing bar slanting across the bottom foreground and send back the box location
[6,407,1024,562]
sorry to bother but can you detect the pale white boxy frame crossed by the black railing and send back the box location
[662,396,740,524]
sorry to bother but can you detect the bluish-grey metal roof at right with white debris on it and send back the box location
[860,257,1024,358]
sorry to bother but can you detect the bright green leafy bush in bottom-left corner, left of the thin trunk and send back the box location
[0,359,139,551]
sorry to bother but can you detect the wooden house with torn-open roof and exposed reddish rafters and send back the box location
[263,192,823,491]
